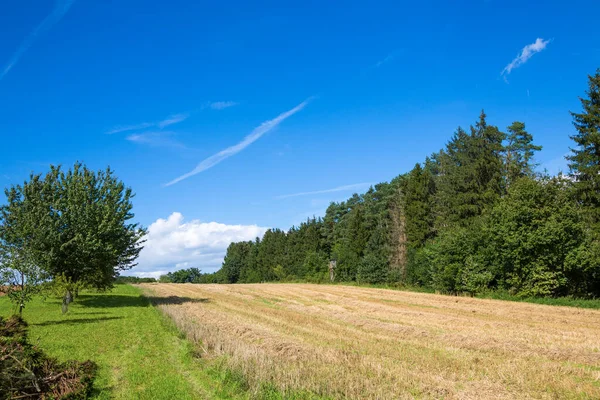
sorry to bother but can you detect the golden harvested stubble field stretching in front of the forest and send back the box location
[142,284,600,399]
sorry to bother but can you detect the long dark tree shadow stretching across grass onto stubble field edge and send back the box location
[75,294,209,308]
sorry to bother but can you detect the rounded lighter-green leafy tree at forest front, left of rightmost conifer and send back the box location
[489,178,585,296]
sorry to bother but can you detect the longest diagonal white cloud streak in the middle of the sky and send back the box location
[165,97,312,186]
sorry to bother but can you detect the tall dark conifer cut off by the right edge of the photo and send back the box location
[567,68,600,231]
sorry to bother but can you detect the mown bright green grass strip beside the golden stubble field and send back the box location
[0,285,241,399]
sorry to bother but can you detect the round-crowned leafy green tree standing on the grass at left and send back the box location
[0,163,146,312]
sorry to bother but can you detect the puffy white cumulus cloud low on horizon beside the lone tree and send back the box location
[127,212,268,277]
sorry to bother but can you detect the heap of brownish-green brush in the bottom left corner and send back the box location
[0,315,97,399]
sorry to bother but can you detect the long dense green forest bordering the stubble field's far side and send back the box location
[161,69,600,297]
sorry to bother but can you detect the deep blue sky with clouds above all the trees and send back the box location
[0,0,600,275]
